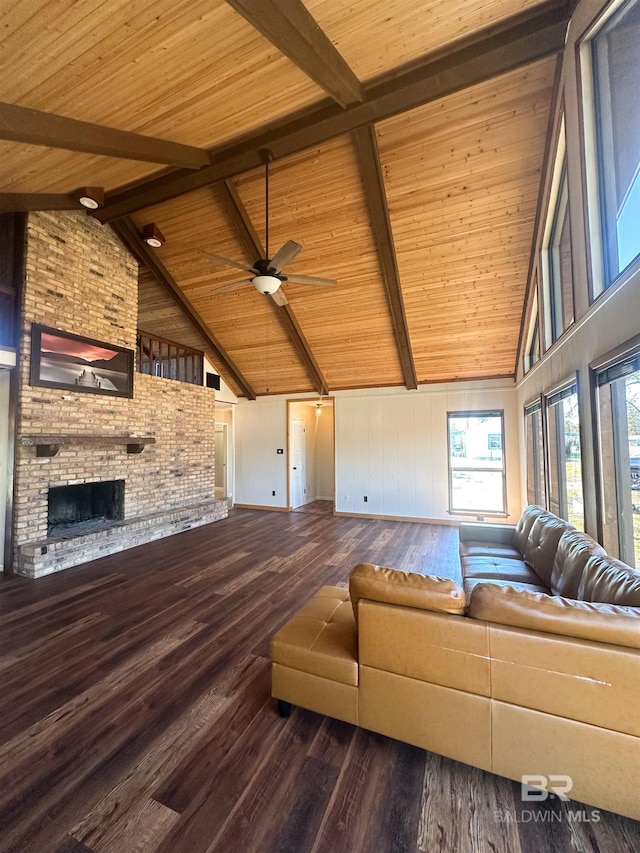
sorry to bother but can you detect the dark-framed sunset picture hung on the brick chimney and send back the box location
[30,323,133,397]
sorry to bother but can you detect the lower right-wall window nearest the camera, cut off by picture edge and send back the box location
[596,348,640,568]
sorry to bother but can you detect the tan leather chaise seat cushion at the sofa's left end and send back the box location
[271,586,358,686]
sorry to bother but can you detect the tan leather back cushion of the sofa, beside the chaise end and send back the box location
[349,563,466,622]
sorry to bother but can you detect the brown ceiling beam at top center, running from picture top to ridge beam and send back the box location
[227,0,364,107]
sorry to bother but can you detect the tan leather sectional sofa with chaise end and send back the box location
[271,507,640,819]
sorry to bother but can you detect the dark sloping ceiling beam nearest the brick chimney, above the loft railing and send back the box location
[112,219,256,400]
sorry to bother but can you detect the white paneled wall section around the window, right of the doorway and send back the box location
[335,381,522,521]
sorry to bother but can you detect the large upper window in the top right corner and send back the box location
[582,0,640,293]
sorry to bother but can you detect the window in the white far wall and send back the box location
[447,411,505,514]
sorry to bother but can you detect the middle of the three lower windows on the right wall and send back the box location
[546,382,584,530]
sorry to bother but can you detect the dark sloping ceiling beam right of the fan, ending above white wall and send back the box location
[354,127,418,390]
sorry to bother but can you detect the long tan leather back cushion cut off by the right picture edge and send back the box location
[468,583,640,649]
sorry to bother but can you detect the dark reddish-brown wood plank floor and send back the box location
[0,507,640,853]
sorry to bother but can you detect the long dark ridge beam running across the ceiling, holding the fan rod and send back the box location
[93,2,571,222]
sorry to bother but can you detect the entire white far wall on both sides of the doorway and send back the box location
[236,380,523,521]
